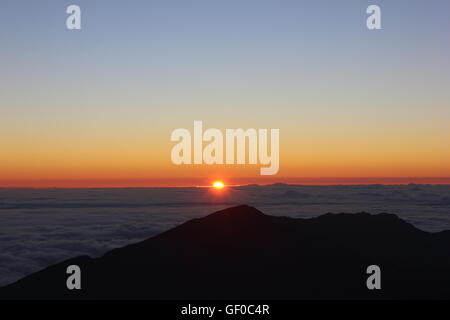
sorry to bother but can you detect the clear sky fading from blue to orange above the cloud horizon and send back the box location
[0,0,450,187]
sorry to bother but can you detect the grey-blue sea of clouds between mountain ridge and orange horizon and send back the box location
[0,184,450,286]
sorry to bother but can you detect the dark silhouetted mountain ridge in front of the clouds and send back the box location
[0,206,450,299]
